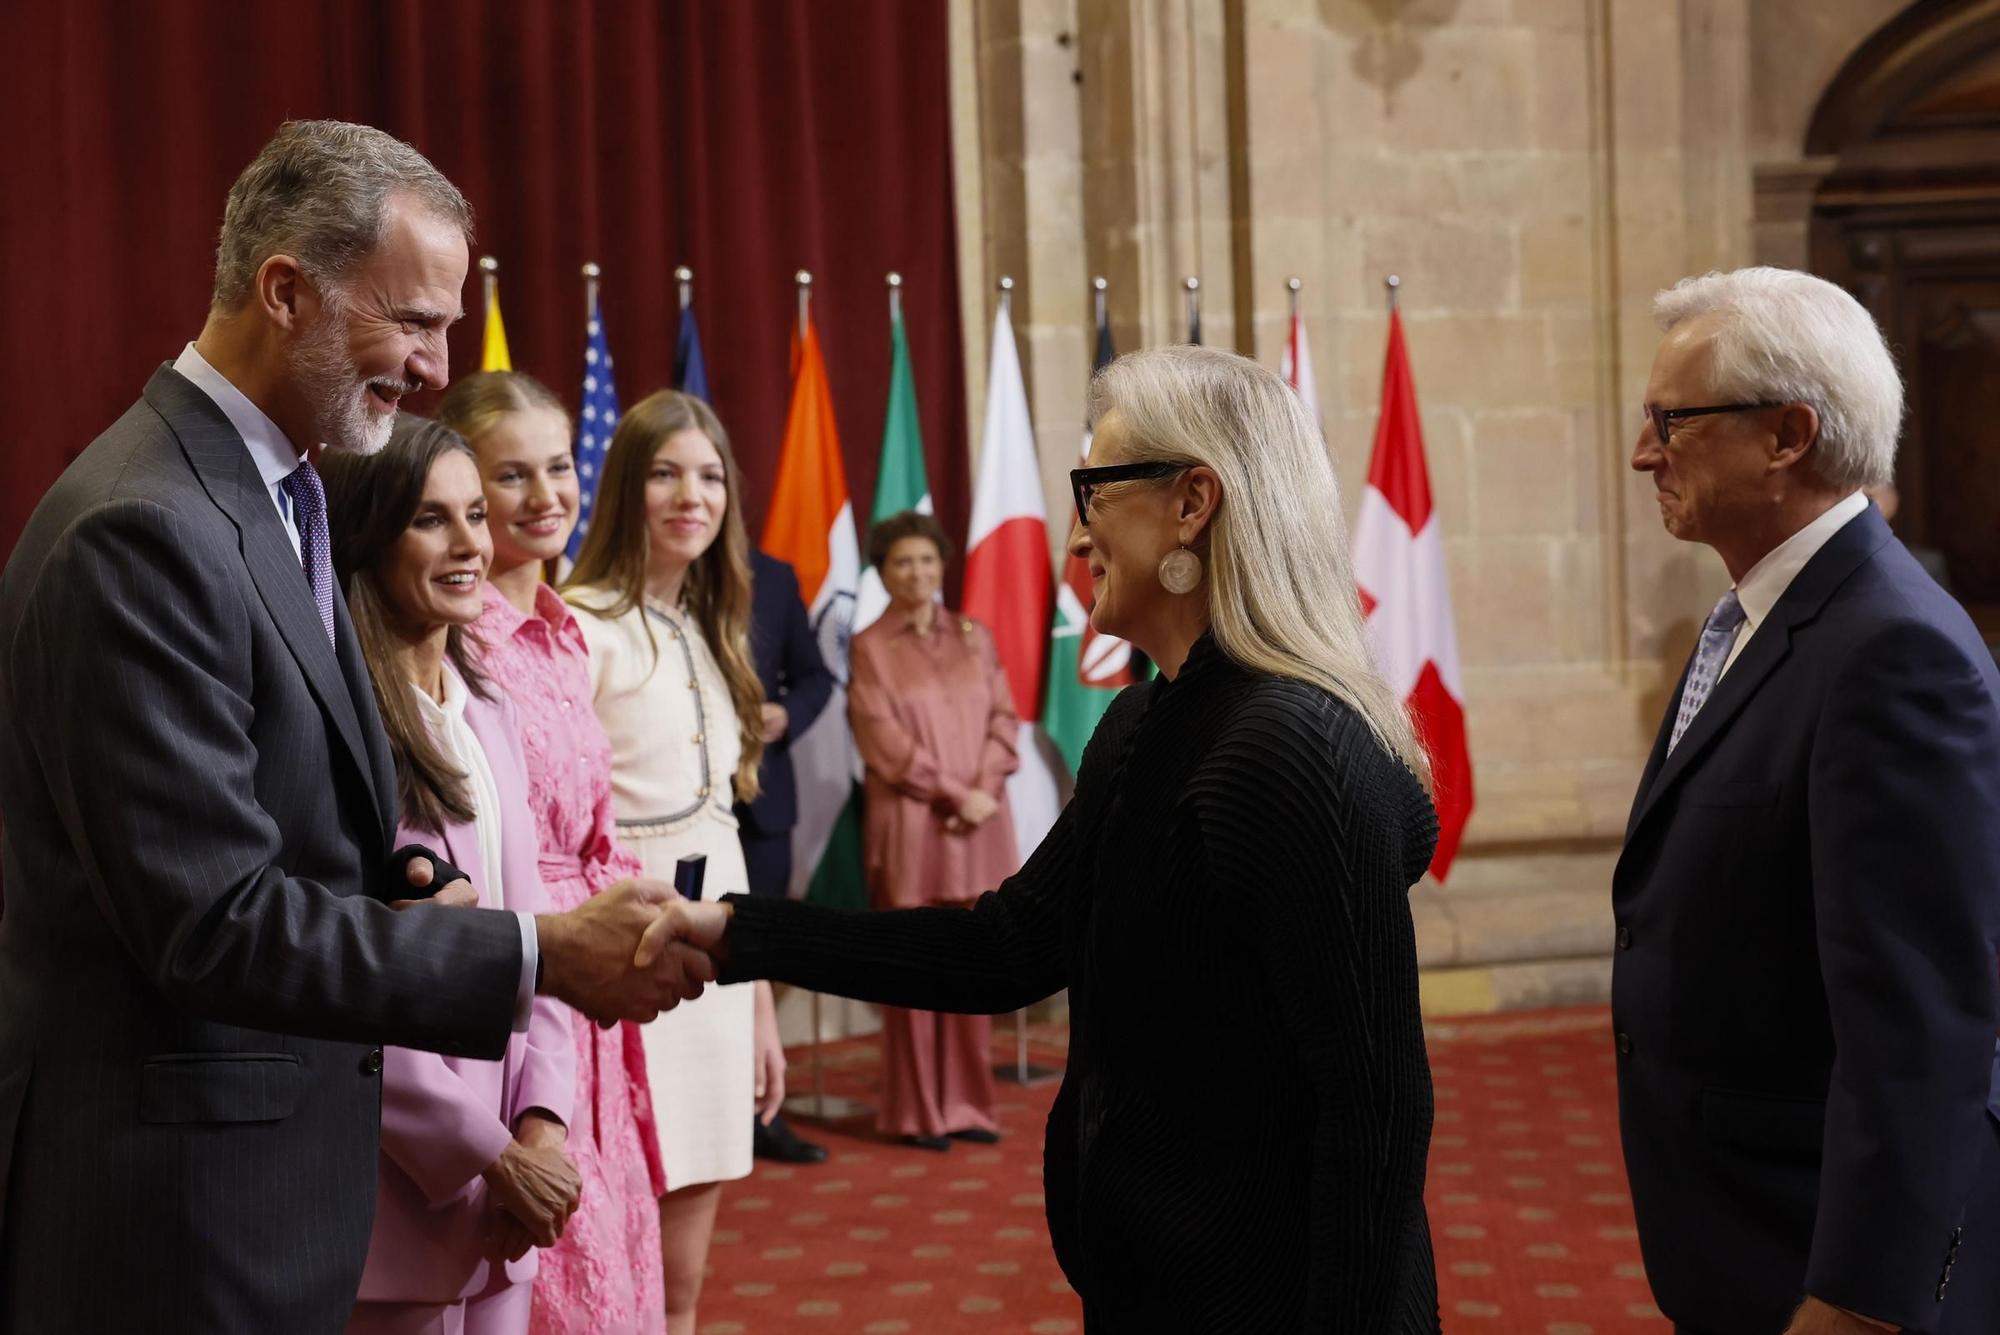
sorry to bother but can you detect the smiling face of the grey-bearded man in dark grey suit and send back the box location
[290,196,468,454]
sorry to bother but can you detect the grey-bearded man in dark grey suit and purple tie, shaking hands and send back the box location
[0,122,712,1335]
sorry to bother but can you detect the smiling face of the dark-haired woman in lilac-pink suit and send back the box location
[376,450,494,636]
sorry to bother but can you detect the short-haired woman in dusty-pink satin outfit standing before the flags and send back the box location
[848,512,1020,1149]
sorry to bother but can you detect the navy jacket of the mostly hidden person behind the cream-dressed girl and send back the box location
[736,548,834,835]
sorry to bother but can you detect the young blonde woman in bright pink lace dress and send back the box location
[438,372,666,1335]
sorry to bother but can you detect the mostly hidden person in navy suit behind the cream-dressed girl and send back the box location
[736,548,834,1163]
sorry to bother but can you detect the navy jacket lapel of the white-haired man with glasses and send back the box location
[1626,506,1890,841]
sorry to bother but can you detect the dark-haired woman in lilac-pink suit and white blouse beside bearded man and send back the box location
[324,418,580,1335]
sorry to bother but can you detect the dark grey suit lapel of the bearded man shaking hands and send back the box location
[146,366,394,841]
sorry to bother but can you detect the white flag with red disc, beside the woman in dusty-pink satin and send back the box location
[966,304,1062,861]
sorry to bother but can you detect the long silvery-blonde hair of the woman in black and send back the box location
[1090,346,1430,785]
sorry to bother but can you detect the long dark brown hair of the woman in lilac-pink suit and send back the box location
[320,414,488,833]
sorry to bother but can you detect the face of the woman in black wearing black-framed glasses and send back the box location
[1070,410,1180,646]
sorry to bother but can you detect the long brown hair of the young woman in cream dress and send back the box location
[562,390,764,801]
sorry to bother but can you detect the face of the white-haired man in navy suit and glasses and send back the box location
[1632,314,1776,546]
